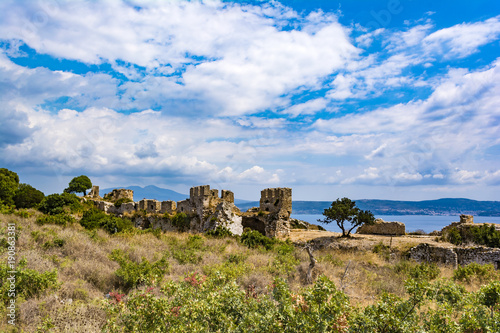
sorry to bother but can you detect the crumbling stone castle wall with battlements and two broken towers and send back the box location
[89,185,292,238]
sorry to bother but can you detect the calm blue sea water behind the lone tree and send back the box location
[292,214,500,232]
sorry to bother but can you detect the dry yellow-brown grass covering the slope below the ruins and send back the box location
[0,211,498,332]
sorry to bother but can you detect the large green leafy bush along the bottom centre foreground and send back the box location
[105,272,351,333]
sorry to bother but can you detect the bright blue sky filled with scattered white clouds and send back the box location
[0,0,500,200]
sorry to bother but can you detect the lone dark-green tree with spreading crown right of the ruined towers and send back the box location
[318,198,375,237]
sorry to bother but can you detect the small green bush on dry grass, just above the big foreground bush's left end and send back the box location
[109,250,168,289]
